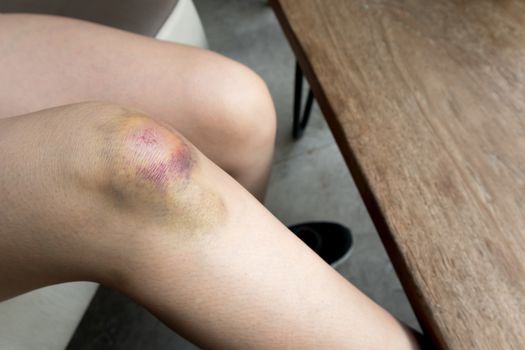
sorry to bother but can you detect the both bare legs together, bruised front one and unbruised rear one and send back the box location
[0,15,422,349]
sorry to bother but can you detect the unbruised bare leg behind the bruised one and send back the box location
[0,14,275,198]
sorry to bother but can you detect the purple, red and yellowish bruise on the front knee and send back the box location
[103,115,224,232]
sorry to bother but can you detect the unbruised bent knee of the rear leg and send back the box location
[188,58,276,170]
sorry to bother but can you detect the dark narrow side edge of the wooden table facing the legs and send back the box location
[269,0,448,349]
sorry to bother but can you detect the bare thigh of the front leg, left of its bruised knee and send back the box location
[0,103,125,301]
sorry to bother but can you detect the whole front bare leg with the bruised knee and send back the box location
[0,103,416,349]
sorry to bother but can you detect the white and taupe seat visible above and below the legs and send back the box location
[0,0,207,350]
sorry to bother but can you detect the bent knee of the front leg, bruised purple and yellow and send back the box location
[73,105,224,230]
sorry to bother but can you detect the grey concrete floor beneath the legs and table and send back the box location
[69,0,418,350]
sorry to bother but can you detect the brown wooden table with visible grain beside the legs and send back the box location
[272,0,525,350]
